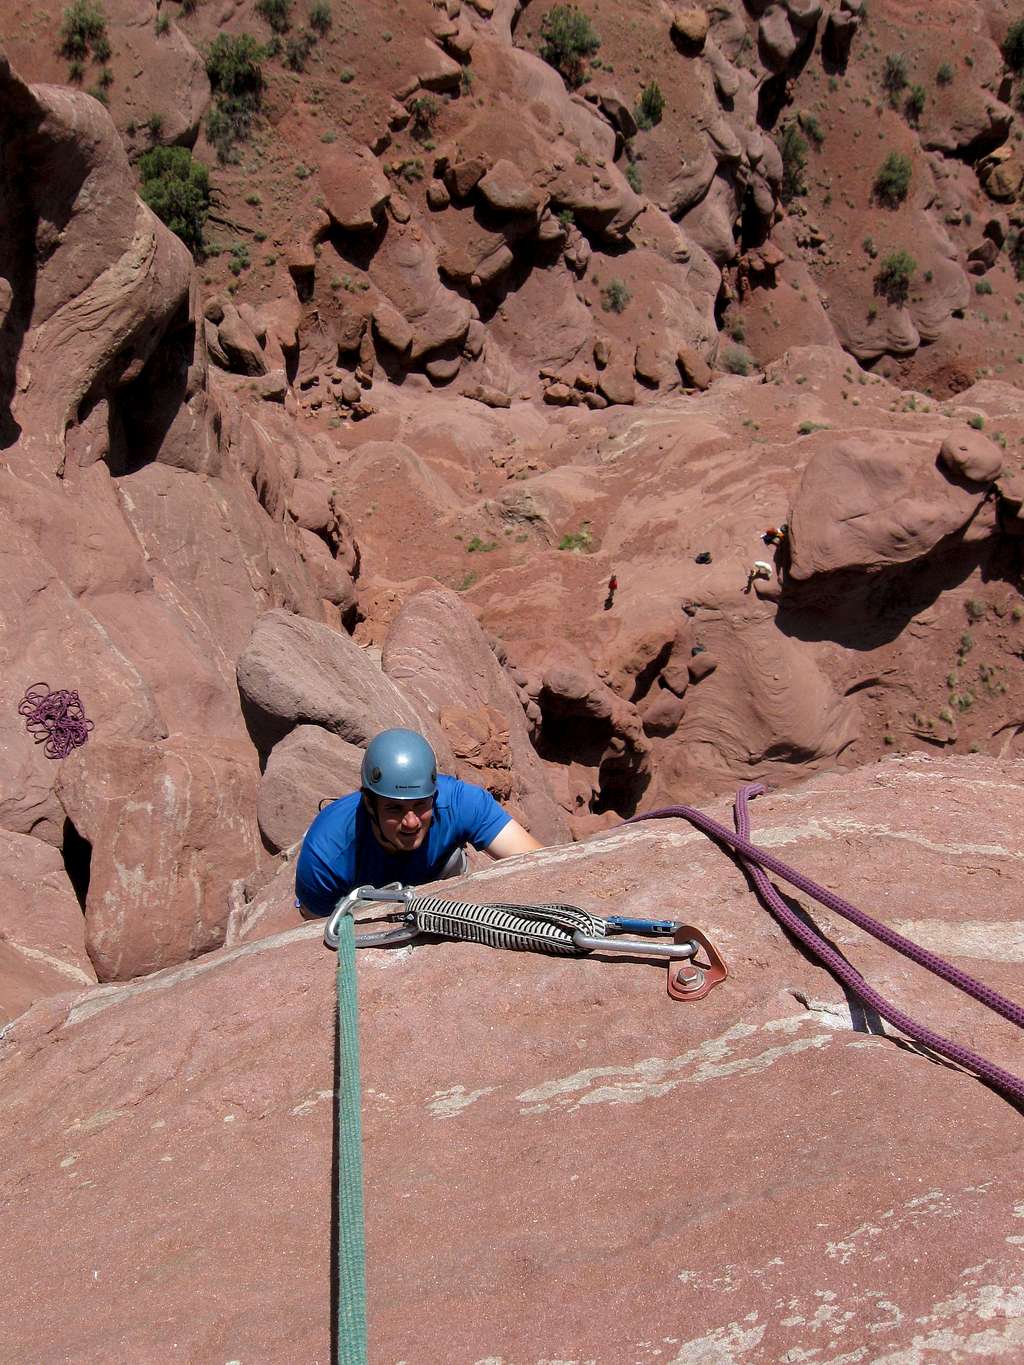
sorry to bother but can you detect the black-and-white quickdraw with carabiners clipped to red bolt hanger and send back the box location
[324,883,728,1001]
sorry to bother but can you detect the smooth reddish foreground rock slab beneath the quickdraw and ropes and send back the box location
[0,759,1024,1365]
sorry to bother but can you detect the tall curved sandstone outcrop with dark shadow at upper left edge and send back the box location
[0,57,193,470]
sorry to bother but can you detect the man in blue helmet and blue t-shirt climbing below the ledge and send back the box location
[295,730,542,919]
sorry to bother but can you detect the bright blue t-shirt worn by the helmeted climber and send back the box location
[295,775,512,915]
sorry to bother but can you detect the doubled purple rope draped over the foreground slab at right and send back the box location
[624,782,1024,1100]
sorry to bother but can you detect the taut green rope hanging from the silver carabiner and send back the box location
[335,915,366,1365]
